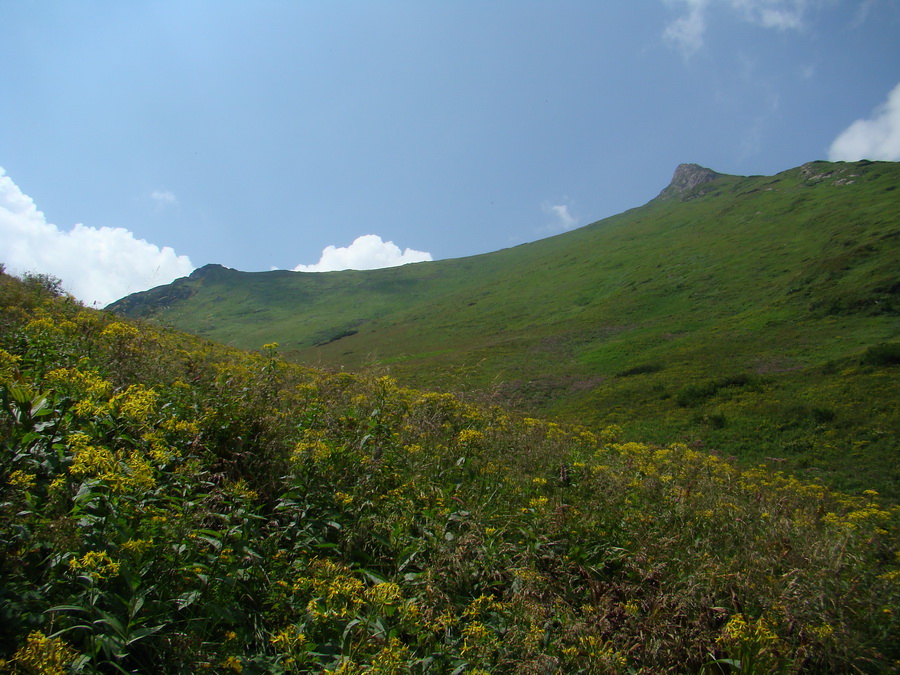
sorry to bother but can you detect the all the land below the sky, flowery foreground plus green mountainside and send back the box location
[0,161,900,675]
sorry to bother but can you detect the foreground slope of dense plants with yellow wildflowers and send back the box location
[0,275,900,673]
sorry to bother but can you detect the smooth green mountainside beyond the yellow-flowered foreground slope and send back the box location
[111,162,900,495]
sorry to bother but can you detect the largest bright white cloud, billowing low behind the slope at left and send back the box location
[0,167,193,306]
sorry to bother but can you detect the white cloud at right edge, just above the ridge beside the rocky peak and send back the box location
[828,84,900,162]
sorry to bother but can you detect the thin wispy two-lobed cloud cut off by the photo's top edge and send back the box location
[663,0,822,57]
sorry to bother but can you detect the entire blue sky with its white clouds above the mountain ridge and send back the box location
[0,0,900,304]
